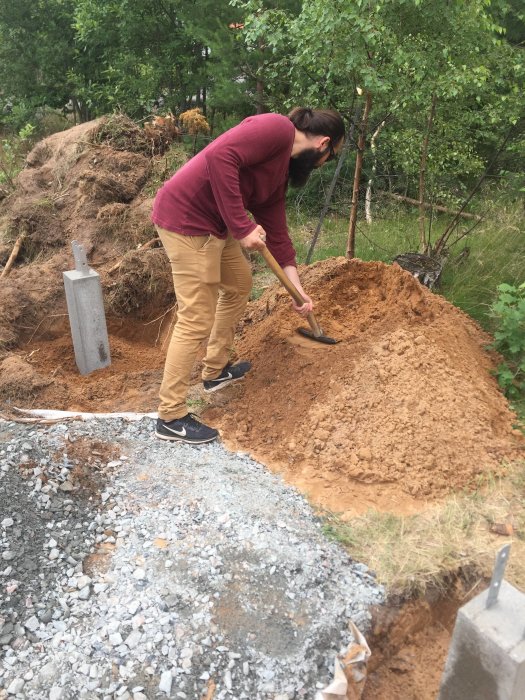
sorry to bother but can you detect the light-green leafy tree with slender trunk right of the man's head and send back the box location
[234,0,525,252]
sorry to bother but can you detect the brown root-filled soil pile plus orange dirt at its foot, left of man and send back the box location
[0,115,174,411]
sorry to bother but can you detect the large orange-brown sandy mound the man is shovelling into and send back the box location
[206,258,523,510]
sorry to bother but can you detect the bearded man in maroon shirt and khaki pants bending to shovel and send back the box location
[152,108,344,444]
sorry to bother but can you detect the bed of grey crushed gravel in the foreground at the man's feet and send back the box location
[0,419,384,700]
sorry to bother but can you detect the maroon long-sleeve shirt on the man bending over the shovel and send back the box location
[152,114,295,266]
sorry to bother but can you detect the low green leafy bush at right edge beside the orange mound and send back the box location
[491,283,525,399]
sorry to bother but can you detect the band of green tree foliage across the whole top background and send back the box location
[0,0,525,209]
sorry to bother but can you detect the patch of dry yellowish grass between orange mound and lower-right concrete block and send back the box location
[322,462,525,595]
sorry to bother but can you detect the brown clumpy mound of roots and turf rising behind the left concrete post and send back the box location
[0,115,176,351]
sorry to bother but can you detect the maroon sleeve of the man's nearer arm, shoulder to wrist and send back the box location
[206,120,290,239]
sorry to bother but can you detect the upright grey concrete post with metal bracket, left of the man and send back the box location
[62,241,111,374]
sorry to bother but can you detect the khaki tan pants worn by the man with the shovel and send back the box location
[156,226,252,421]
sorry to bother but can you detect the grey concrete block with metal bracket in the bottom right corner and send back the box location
[438,581,525,700]
